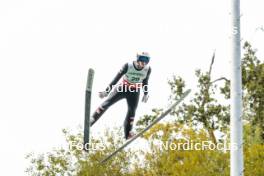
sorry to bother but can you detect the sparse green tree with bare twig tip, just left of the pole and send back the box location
[138,51,230,144]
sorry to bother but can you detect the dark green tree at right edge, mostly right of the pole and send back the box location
[221,42,264,143]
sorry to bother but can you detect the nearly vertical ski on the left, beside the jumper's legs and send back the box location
[83,68,94,152]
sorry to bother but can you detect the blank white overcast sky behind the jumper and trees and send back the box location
[0,0,264,176]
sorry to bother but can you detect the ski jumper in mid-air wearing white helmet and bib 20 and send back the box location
[91,52,151,139]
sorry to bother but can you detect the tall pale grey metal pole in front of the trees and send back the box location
[230,0,244,176]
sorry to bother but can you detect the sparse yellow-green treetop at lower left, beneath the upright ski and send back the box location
[26,129,134,176]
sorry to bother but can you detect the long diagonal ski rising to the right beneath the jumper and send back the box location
[101,89,191,163]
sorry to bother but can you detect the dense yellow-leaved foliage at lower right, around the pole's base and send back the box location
[134,123,264,176]
